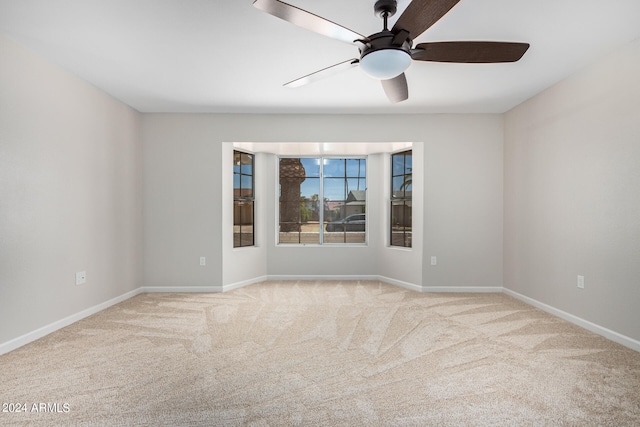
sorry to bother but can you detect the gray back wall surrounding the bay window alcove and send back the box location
[143,114,503,288]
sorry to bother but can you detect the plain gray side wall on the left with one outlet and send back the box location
[0,36,142,344]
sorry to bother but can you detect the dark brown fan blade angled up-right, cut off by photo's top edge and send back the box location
[391,0,460,40]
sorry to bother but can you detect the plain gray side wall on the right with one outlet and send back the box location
[504,41,640,340]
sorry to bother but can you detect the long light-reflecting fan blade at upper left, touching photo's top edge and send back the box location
[253,0,365,43]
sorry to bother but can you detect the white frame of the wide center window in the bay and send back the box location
[275,155,369,247]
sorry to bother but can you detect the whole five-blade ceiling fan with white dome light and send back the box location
[253,0,529,103]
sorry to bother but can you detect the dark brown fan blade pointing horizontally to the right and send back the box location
[411,41,529,64]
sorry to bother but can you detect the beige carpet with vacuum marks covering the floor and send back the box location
[0,282,640,426]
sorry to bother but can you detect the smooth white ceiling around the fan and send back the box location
[0,0,640,113]
